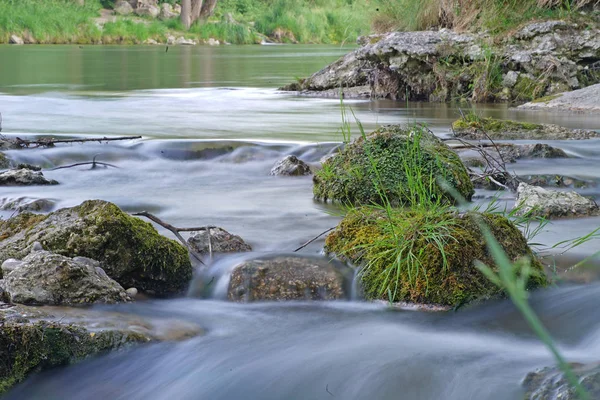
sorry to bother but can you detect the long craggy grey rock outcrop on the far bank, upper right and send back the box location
[283,21,600,102]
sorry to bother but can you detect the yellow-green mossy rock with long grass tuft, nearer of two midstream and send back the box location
[325,207,546,306]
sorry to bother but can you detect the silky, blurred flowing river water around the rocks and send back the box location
[0,46,600,400]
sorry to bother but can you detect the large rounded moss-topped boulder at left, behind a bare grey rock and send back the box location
[0,200,192,296]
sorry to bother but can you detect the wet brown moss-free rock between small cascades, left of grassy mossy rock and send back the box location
[228,256,352,301]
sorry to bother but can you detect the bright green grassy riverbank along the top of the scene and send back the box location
[0,0,593,44]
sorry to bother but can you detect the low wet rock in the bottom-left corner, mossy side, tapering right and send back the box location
[0,303,202,395]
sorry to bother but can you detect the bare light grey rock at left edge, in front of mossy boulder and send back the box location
[3,251,129,305]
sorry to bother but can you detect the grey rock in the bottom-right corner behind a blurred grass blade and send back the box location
[523,363,600,400]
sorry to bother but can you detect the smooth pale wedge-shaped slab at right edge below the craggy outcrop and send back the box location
[519,84,600,113]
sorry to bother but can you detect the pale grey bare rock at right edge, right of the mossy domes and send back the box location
[515,183,599,218]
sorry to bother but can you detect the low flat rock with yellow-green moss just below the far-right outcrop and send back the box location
[452,117,600,140]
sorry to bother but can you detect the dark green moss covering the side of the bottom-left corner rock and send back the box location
[0,321,148,395]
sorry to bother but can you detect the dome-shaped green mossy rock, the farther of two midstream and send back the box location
[313,125,474,205]
